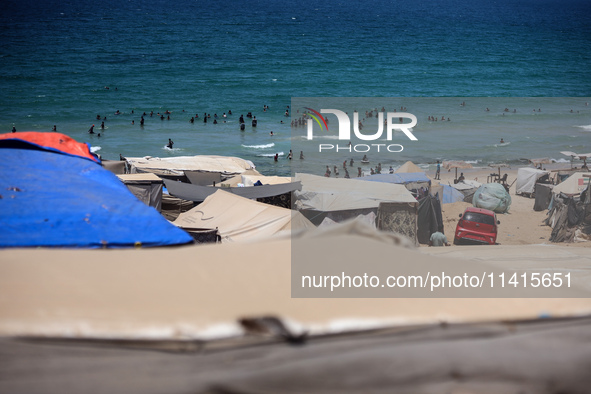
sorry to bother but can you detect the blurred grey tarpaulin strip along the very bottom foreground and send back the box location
[0,317,591,394]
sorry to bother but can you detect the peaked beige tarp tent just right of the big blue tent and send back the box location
[173,189,314,242]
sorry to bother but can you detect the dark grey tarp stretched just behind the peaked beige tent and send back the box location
[164,179,301,202]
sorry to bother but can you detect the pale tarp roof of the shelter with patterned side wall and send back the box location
[294,174,417,212]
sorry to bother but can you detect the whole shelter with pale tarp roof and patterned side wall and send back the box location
[294,174,418,241]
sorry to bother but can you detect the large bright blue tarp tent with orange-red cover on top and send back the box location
[0,133,192,248]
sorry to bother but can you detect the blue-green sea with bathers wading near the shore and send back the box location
[0,0,591,175]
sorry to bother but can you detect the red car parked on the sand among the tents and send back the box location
[454,207,501,245]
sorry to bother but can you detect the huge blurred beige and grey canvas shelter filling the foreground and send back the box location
[0,222,591,394]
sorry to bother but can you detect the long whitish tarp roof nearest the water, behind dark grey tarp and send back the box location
[125,156,255,176]
